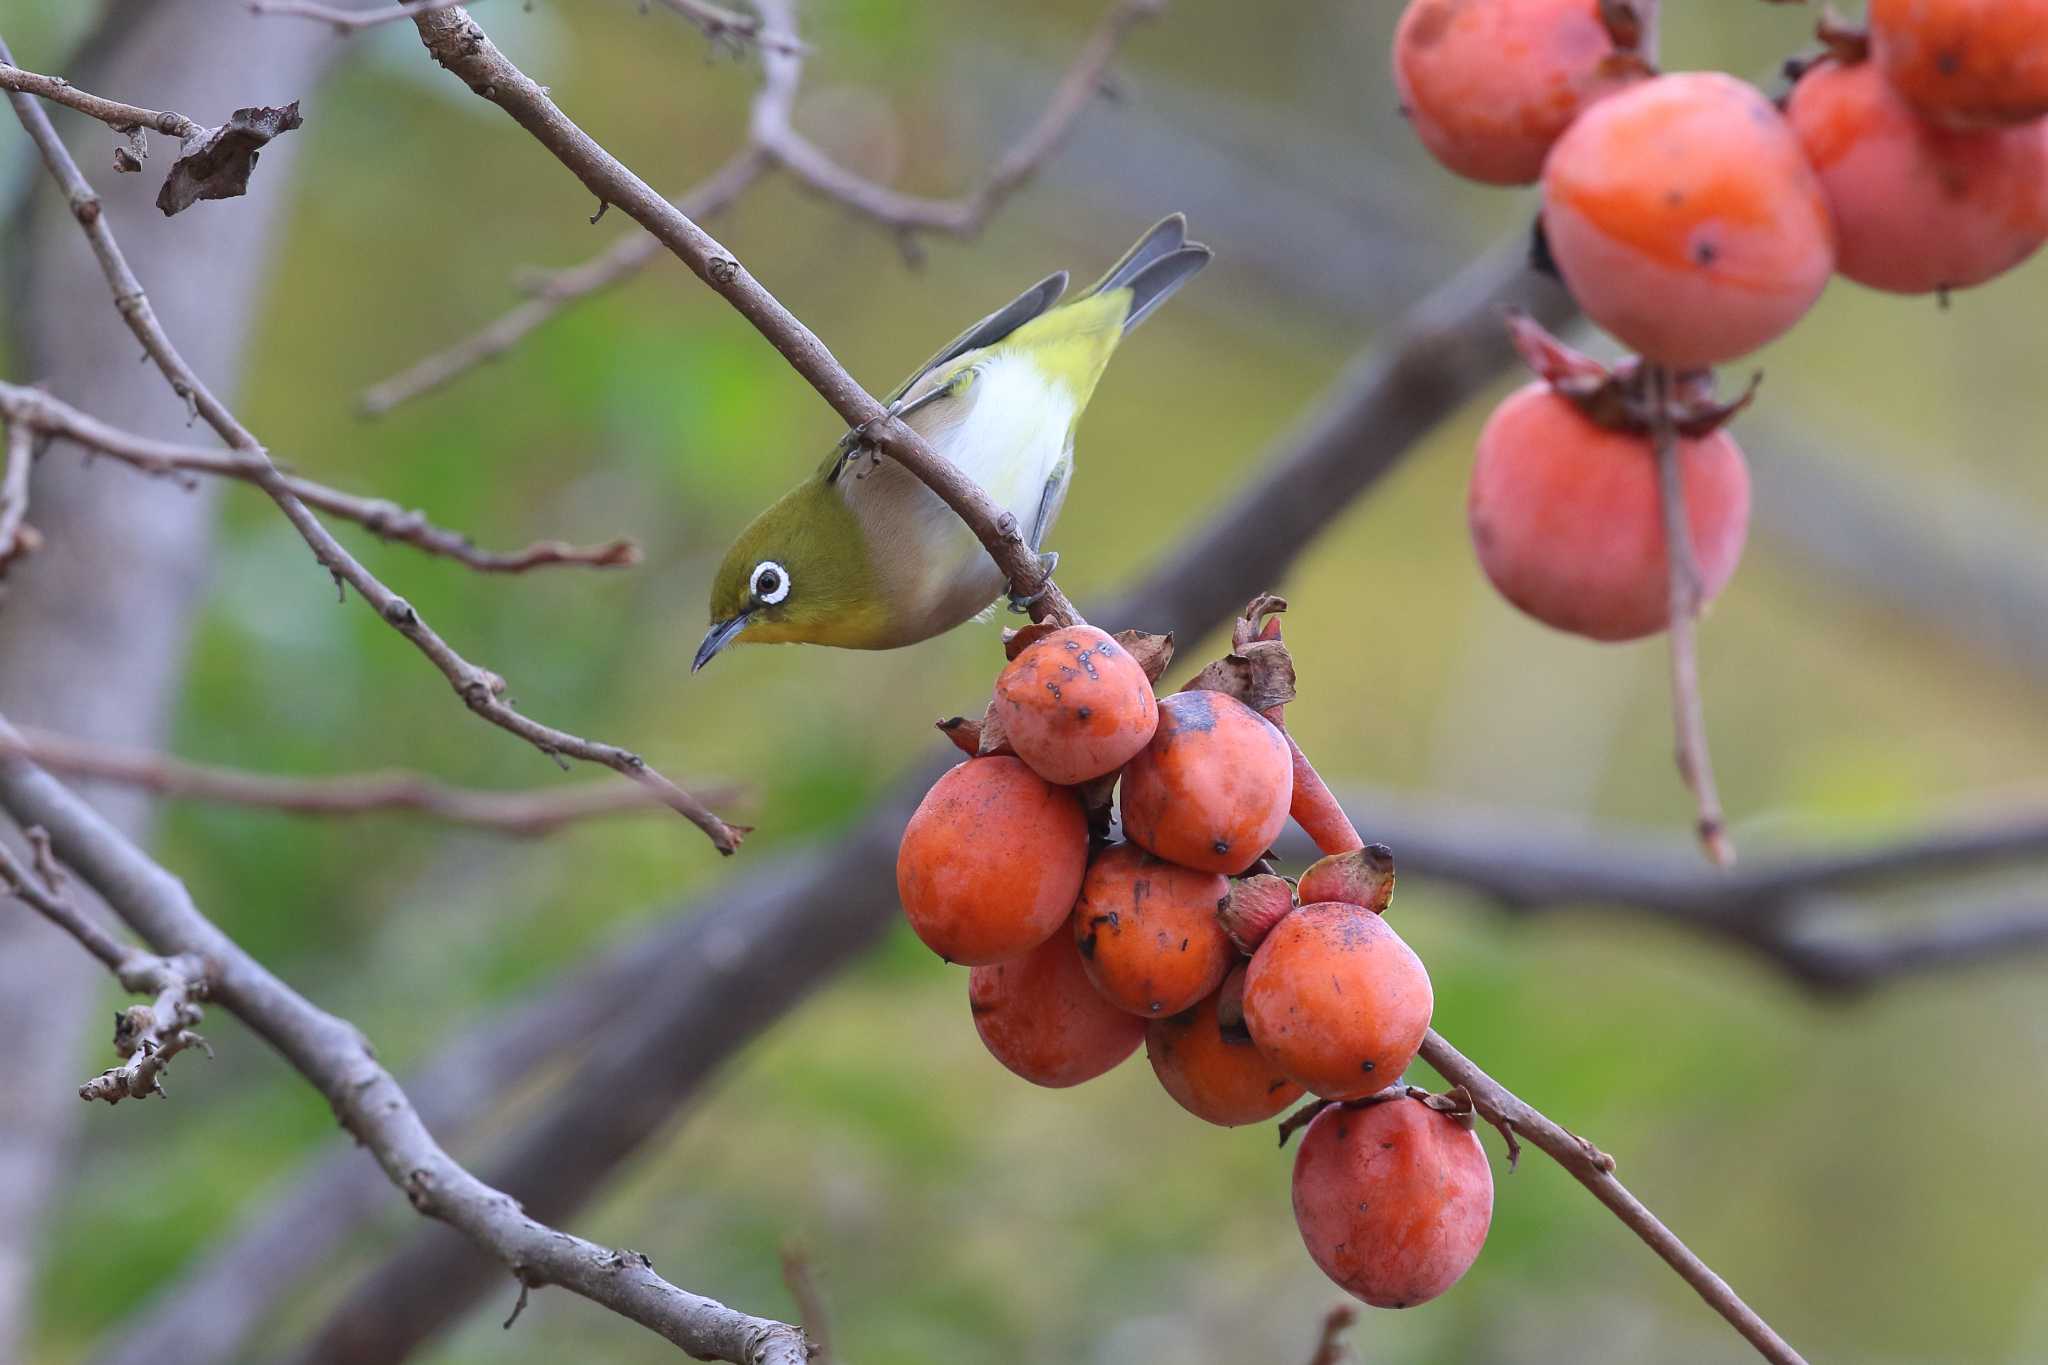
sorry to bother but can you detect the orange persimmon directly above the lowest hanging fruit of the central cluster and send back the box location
[1245,900,1436,1099]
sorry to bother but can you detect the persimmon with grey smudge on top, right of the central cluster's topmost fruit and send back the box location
[1118,692,1294,876]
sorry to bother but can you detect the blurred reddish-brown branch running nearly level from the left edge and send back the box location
[0,726,735,839]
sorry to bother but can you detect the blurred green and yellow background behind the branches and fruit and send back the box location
[0,0,2048,1365]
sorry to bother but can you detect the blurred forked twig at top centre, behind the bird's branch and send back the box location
[362,0,1165,415]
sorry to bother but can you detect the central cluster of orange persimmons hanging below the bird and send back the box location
[897,598,1493,1308]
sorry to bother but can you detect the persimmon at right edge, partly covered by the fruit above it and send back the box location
[1786,61,2048,295]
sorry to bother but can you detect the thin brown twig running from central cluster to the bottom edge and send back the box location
[1421,1029,1806,1365]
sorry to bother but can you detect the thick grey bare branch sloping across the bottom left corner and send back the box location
[0,722,807,1365]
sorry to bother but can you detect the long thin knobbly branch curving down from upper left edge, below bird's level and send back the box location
[0,53,745,853]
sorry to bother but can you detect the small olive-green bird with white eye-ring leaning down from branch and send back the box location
[690,213,1210,673]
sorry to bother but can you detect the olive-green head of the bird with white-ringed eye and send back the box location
[690,481,881,673]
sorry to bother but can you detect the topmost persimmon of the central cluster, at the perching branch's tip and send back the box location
[995,626,1159,786]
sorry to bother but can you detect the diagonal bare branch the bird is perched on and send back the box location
[414,10,1081,626]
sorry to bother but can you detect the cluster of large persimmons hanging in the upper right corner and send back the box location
[1393,0,2048,641]
